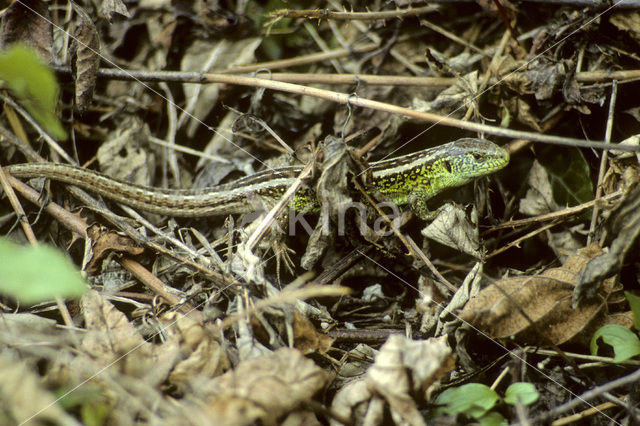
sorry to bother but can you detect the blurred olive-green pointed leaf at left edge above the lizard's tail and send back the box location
[0,44,67,140]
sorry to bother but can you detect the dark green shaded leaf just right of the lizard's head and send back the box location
[537,146,593,206]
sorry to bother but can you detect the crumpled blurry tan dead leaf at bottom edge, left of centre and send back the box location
[204,348,328,425]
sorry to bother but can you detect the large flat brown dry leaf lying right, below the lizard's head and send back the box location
[460,244,613,345]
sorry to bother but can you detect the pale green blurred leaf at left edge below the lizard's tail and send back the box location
[0,239,86,304]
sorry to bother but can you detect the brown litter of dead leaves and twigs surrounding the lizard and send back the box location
[0,1,640,424]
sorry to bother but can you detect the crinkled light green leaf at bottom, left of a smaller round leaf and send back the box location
[435,383,500,419]
